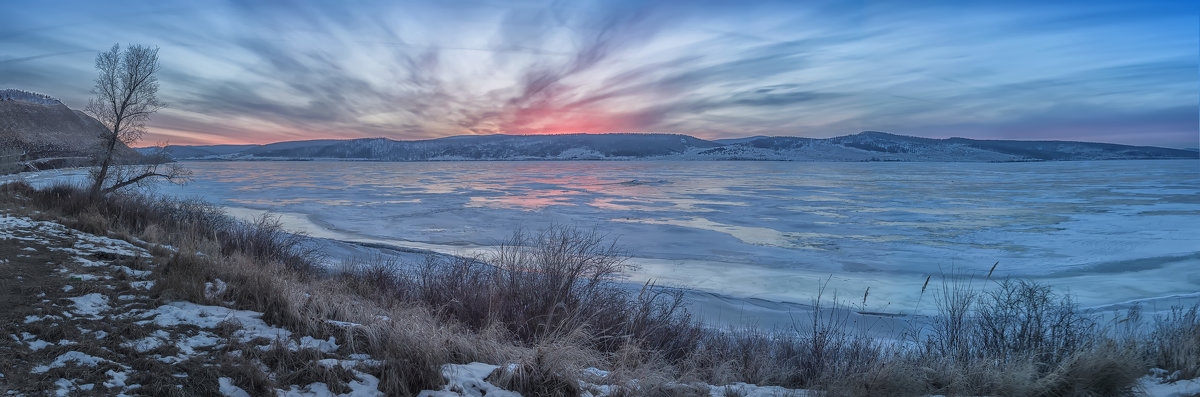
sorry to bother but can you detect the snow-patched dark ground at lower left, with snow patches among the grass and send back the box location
[0,212,825,397]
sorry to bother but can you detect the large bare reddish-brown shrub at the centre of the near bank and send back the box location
[409,227,700,357]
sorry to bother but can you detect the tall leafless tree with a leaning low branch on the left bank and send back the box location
[84,44,190,197]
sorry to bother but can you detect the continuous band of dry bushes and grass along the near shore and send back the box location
[0,184,1200,396]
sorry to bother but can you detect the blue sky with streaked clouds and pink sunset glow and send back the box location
[0,0,1200,148]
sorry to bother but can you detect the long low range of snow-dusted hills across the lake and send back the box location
[152,131,1200,162]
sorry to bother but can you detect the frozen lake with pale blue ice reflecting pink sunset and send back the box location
[18,161,1200,326]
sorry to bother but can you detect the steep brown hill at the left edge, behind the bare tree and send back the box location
[0,89,142,169]
